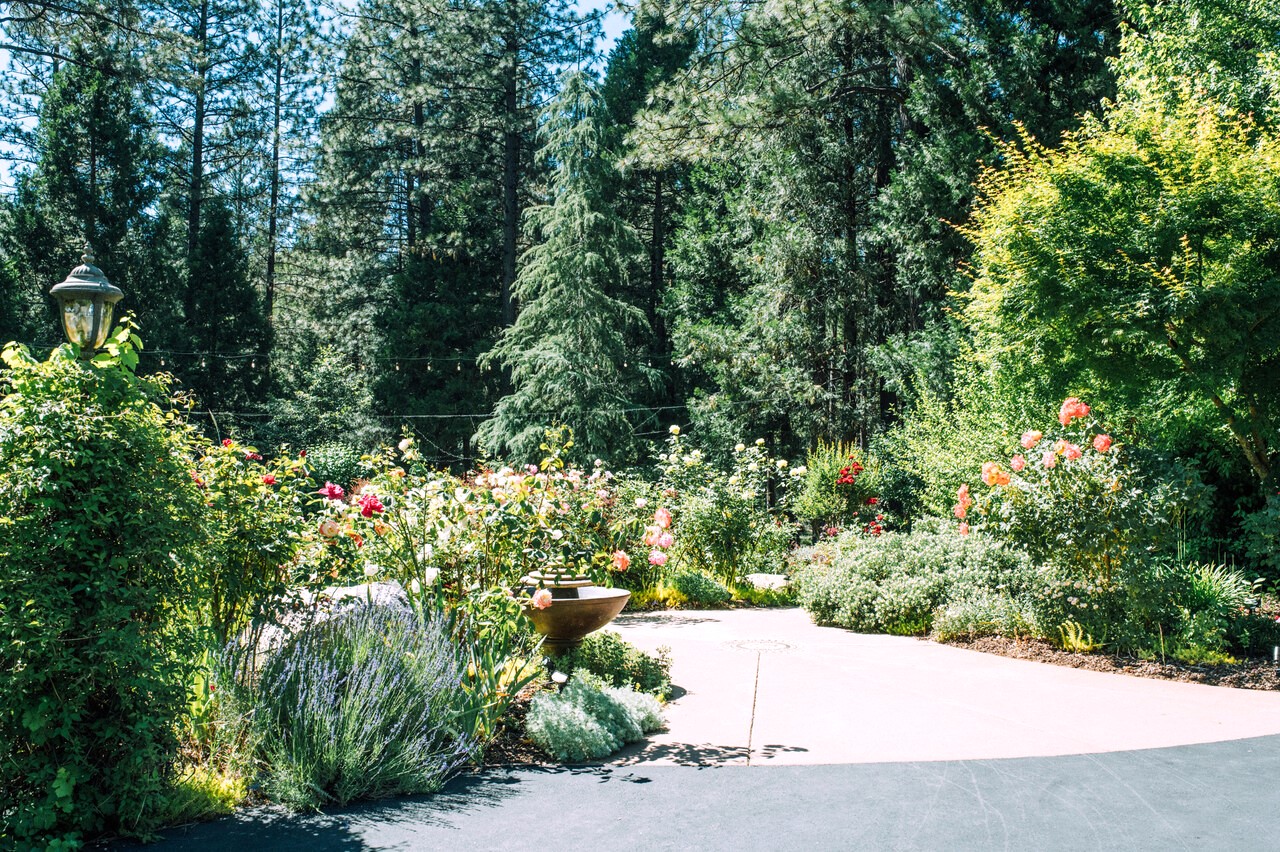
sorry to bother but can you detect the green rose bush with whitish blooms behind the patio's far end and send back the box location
[659,426,805,585]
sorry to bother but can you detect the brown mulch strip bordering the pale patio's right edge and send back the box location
[947,636,1280,690]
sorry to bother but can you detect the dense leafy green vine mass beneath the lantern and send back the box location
[0,335,204,849]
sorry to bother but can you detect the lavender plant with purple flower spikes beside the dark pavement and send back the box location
[224,603,477,810]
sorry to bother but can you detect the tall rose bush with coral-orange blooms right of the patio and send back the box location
[954,397,1204,650]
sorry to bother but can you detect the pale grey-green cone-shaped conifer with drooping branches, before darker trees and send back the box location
[480,72,654,463]
